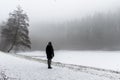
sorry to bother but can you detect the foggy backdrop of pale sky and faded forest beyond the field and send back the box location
[0,0,120,50]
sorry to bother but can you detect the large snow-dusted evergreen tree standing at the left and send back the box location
[2,6,31,52]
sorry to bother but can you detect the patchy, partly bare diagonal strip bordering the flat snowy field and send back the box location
[14,55,120,80]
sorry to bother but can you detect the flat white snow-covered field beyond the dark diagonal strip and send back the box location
[19,51,120,71]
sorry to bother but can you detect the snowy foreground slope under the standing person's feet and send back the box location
[0,52,119,80]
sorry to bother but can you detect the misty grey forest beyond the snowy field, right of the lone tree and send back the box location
[31,10,120,50]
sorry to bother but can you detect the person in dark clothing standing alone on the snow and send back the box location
[46,42,54,69]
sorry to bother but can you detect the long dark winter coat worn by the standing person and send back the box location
[46,44,54,59]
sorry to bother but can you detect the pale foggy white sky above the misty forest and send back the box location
[0,0,120,23]
